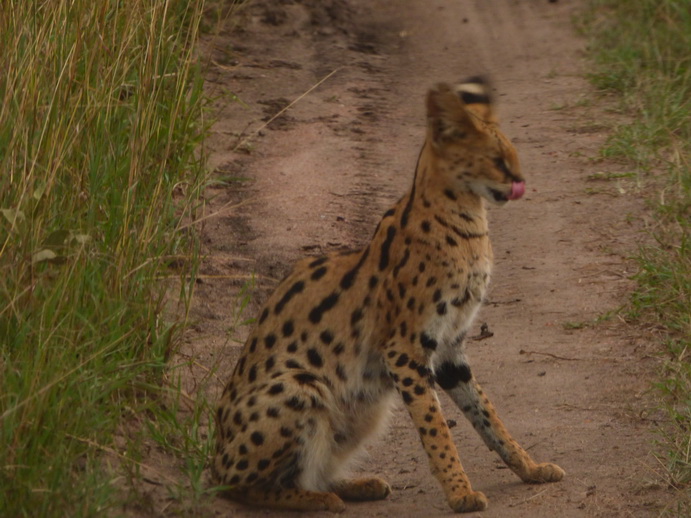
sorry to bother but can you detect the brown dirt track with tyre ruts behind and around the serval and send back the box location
[146,0,670,517]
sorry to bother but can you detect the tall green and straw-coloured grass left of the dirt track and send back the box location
[0,0,203,517]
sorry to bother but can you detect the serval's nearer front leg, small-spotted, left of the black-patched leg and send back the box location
[385,346,487,512]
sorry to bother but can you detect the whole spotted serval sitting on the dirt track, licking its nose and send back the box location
[212,77,564,512]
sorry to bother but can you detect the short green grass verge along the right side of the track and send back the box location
[584,0,691,516]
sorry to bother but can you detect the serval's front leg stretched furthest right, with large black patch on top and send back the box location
[435,355,564,484]
